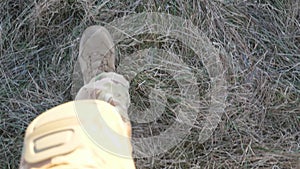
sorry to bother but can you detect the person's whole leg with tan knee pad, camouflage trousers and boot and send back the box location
[20,26,135,169]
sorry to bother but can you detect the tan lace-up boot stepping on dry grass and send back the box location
[78,26,115,84]
